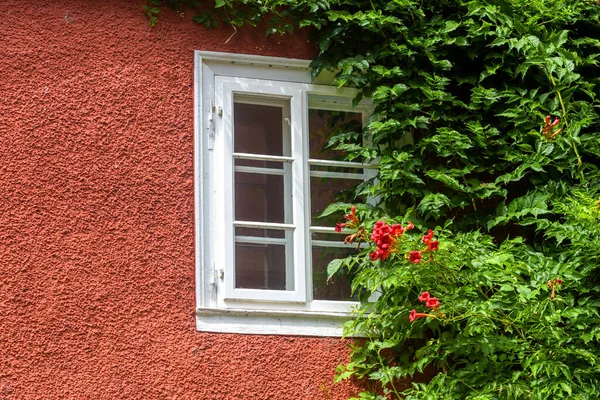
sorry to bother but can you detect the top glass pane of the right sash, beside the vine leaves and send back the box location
[308,109,362,161]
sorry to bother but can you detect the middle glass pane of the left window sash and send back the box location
[235,172,285,223]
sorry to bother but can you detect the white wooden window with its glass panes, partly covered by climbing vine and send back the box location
[195,52,374,336]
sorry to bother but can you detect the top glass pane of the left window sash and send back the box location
[233,96,290,156]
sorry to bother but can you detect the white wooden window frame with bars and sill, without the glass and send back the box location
[194,51,375,336]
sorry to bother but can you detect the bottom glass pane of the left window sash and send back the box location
[235,228,294,290]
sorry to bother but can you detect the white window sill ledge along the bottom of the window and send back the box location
[196,308,352,337]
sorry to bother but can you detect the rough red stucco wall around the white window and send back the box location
[0,0,355,399]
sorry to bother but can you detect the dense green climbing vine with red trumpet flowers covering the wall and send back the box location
[146,0,600,399]
